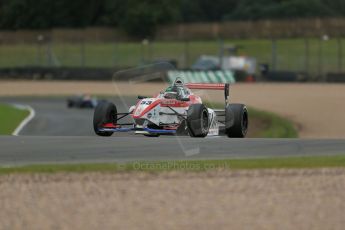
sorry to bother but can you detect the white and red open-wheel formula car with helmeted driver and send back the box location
[93,78,248,138]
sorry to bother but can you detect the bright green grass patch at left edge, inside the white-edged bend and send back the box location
[0,104,29,135]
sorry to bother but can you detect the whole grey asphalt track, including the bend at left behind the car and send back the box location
[0,98,345,166]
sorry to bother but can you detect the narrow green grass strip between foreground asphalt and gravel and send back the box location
[0,156,345,174]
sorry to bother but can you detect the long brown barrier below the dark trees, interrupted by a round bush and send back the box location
[0,17,345,44]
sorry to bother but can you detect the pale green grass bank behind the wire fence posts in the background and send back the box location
[0,38,345,74]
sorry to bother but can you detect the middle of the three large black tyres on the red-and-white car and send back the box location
[187,104,209,137]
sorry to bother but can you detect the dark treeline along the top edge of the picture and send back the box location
[0,0,345,37]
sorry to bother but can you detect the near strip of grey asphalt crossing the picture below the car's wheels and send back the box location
[0,136,345,165]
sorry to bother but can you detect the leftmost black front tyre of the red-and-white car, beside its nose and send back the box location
[93,101,117,137]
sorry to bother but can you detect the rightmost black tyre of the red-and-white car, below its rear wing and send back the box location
[225,104,249,138]
